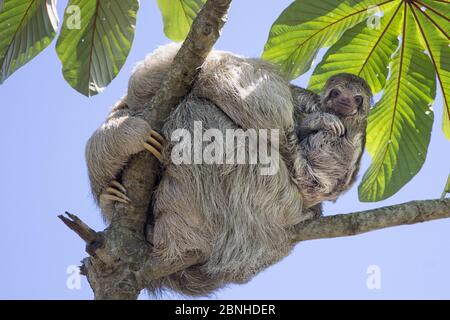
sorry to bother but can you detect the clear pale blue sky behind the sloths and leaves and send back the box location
[0,0,450,299]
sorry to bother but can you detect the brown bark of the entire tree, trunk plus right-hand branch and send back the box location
[59,0,450,299]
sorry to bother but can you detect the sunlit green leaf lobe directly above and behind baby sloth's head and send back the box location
[308,5,402,93]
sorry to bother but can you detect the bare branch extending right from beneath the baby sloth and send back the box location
[293,199,450,242]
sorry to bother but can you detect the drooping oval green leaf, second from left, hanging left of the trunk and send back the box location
[56,0,139,96]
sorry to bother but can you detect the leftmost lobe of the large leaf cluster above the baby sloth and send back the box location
[263,0,395,78]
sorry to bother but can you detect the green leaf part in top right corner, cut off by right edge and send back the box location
[411,1,450,140]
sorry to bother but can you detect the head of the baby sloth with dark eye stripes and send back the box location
[322,73,372,118]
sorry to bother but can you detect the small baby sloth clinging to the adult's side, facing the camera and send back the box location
[292,73,372,208]
